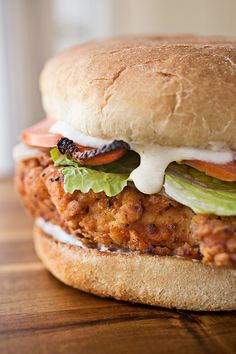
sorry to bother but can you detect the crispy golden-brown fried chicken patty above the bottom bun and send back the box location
[16,153,236,268]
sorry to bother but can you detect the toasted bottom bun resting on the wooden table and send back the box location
[34,226,236,311]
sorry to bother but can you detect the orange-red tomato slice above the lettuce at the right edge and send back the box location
[184,160,236,182]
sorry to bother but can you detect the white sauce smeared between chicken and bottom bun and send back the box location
[35,218,133,254]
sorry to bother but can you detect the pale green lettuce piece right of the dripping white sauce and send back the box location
[164,163,236,216]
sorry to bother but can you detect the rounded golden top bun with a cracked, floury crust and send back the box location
[40,37,236,149]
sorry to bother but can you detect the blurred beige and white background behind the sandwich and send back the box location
[0,0,236,177]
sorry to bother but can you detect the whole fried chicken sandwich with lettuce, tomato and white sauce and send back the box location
[14,37,236,310]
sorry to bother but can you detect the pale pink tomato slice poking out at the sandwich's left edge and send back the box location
[21,118,61,148]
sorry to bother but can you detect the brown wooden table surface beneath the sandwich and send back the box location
[0,180,236,354]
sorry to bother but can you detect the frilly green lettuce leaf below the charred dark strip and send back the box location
[51,148,129,197]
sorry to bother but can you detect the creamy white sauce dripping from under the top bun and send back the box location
[50,121,234,194]
